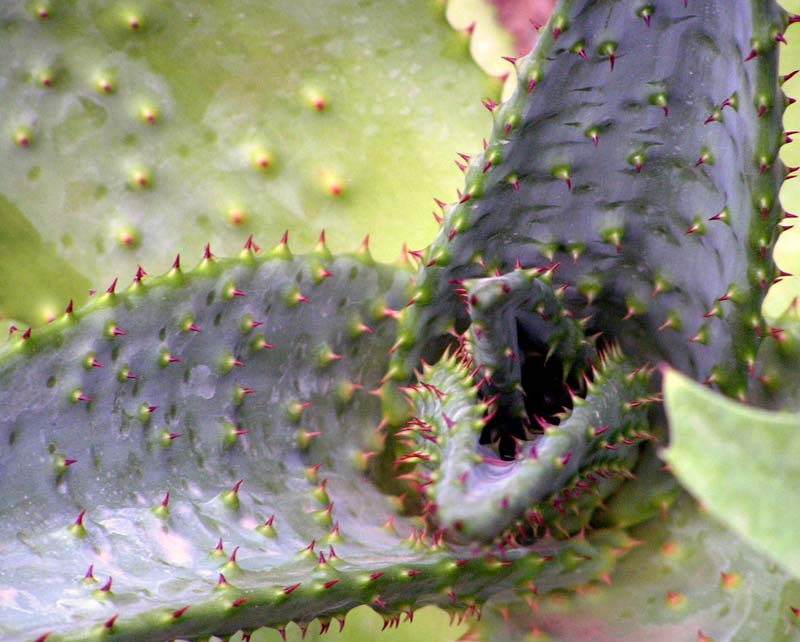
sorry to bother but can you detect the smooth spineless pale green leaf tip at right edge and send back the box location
[664,370,800,577]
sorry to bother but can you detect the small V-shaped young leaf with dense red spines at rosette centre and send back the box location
[406,340,650,541]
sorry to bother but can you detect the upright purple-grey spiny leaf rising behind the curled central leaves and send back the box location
[395,0,786,397]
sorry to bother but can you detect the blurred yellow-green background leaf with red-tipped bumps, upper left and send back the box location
[0,0,499,325]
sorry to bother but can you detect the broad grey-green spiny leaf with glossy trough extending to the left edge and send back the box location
[0,242,626,642]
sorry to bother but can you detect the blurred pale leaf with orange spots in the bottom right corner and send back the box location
[476,498,800,642]
